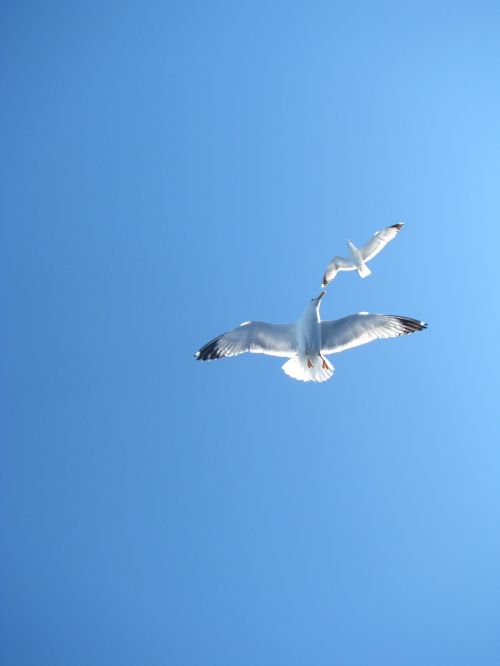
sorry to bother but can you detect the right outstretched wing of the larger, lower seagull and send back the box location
[321,312,427,354]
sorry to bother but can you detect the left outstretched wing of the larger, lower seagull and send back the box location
[195,321,297,361]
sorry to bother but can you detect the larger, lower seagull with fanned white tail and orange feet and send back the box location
[195,291,427,382]
